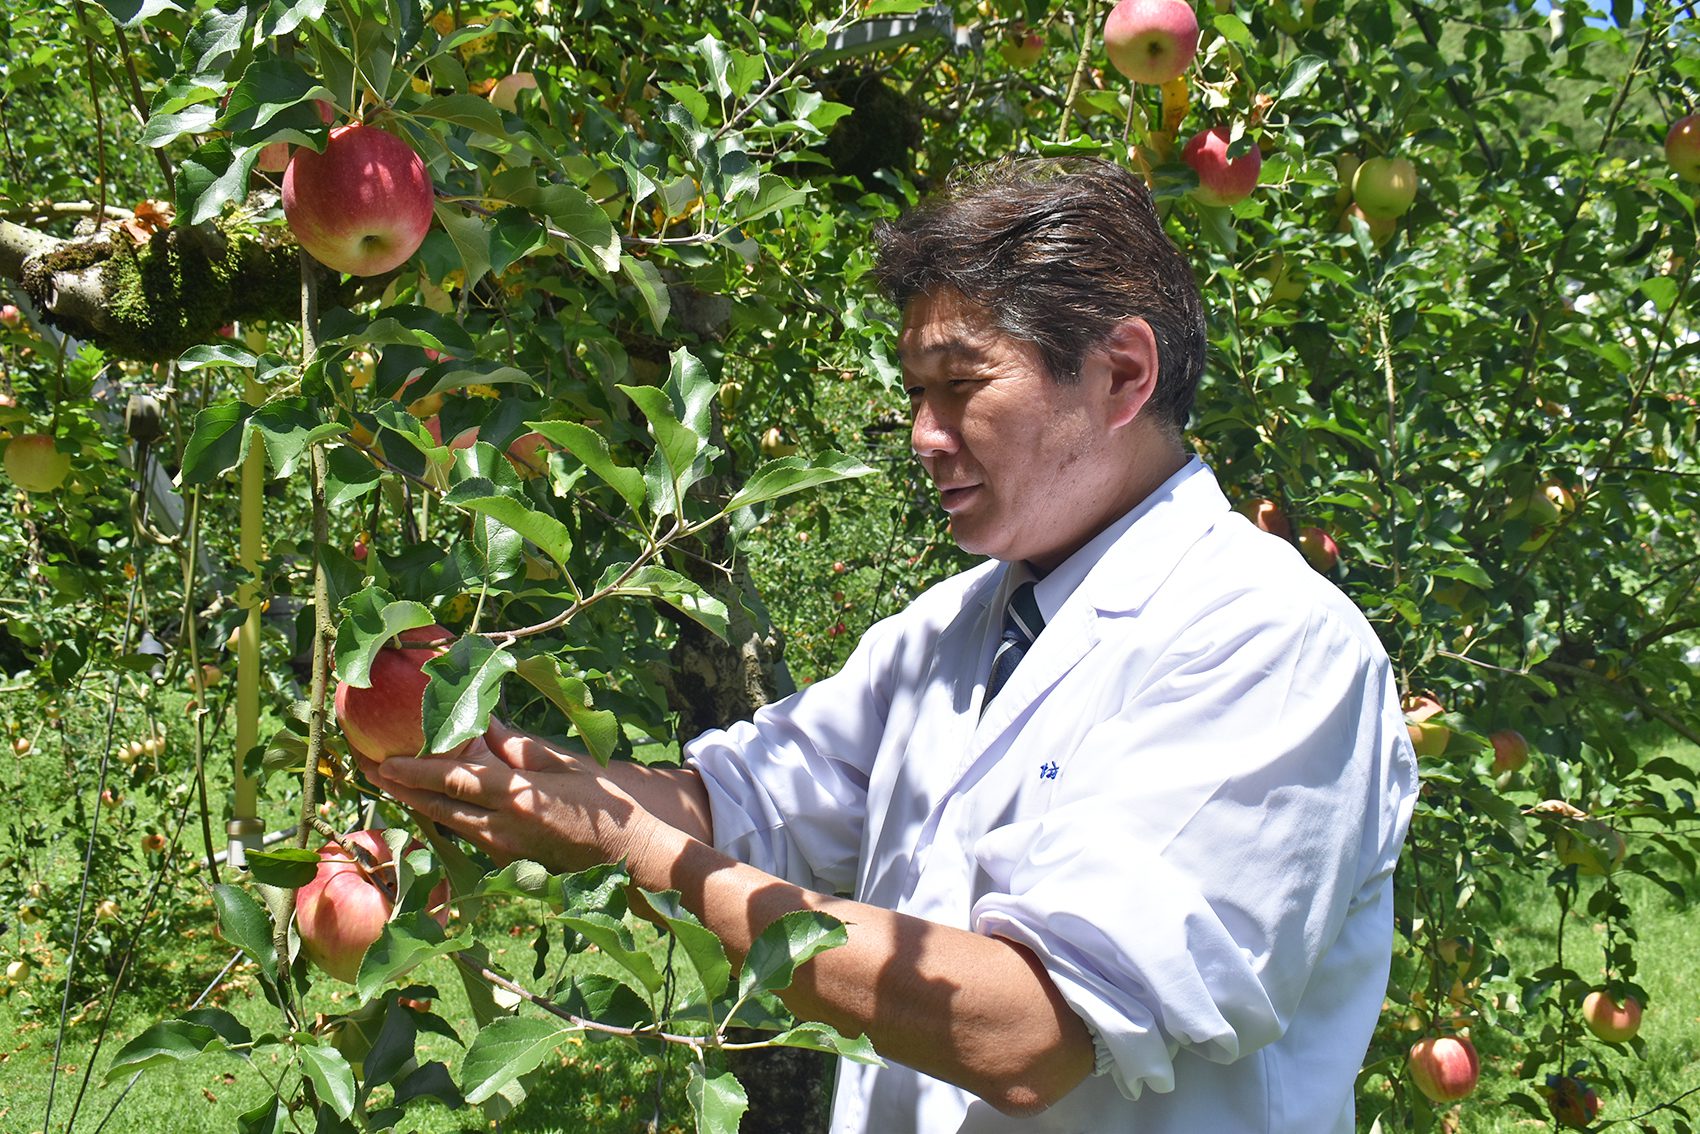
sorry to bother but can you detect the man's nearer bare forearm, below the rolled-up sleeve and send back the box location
[627,816,1093,1114]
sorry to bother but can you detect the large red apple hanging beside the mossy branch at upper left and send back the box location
[284,124,434,275]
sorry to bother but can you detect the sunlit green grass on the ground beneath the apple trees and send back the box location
[0,683,1700,1134]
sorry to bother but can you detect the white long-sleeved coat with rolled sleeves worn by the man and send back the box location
[687,459,1416,1134]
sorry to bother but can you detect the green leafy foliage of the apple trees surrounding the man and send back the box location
[0,0,1700,1131]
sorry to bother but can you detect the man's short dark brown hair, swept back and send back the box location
[874,158,1205,432]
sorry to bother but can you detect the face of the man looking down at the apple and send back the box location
[898,291,1125,571]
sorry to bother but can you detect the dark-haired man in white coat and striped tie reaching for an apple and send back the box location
[369,162,1416,1134]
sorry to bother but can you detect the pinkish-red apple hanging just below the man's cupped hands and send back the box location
[296,831,449,984]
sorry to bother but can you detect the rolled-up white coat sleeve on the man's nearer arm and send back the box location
[971,602,1414,1098]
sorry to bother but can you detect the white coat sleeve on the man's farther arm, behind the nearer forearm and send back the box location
[685,615,901,894]
